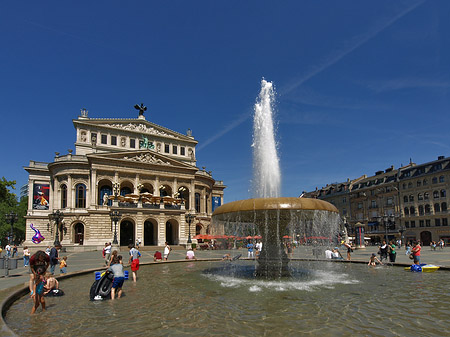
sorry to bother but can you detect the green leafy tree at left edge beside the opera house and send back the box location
[0,177,28,246]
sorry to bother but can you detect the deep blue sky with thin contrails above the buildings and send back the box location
[0,0,450,201]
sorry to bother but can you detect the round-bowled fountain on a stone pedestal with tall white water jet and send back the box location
[213,79,339,278]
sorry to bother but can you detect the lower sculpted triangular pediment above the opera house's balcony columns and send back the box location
[87,150,197,170]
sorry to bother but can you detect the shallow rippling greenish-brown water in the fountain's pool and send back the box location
[6,261,450,337]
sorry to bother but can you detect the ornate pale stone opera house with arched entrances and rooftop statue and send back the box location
[24,104,225,249]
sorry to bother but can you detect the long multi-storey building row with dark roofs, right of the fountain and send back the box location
[305,156,450,245]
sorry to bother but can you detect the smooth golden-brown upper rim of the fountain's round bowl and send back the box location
[212,197,339,217]
